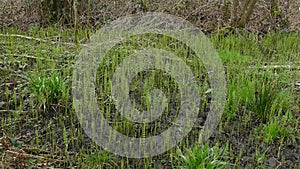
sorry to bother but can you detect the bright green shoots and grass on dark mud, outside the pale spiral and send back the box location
[0,27,300,168]
